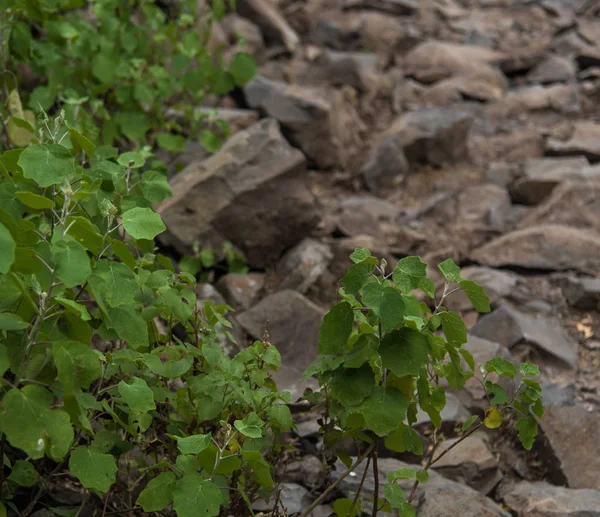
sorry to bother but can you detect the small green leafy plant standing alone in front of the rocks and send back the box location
[305,248,543,517]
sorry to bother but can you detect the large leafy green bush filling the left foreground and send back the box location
[0,116,292,517]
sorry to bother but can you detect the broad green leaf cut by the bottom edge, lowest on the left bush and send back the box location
[173,473,223,517]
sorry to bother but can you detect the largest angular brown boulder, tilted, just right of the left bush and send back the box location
[157,119,320,267]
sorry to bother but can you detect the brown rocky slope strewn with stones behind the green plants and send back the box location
[160,0,600,517]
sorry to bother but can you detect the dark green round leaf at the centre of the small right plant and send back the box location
[379,327,429,377]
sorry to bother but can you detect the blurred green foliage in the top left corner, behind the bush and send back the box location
[0,0,256,153]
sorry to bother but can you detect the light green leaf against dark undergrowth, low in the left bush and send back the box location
[69,447,117,494]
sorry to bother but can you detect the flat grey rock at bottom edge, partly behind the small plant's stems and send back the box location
[331,458,510,517]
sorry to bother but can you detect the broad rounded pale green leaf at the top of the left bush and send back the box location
[18,144,75,188]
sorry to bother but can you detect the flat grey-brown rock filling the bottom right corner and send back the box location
[500,481,600,517]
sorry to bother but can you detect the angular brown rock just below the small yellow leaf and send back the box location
[433,433,502,495]
